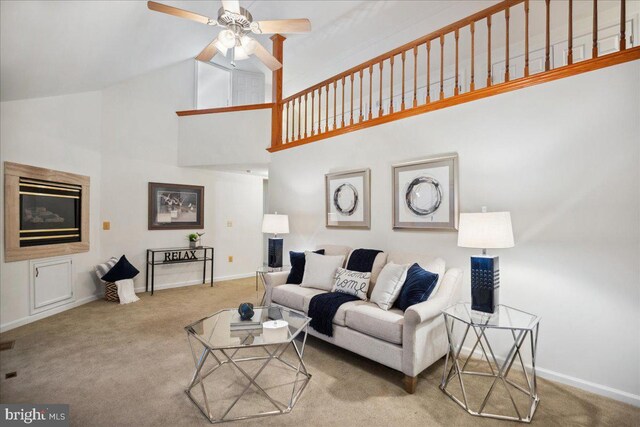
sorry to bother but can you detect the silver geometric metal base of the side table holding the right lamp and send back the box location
[440,313,540,423]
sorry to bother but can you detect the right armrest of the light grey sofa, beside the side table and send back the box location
[404,268,462,325]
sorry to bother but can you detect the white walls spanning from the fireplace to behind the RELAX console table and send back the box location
[0,61,263,330]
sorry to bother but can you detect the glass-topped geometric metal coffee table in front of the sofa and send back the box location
[185,307,311,423]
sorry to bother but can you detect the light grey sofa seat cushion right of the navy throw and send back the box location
[345,302,404,344]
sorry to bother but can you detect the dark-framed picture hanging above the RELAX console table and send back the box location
[149,182,204,230]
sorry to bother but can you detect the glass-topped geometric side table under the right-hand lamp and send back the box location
[440,303,540,423]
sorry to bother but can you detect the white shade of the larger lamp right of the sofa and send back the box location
[458,212,514,249]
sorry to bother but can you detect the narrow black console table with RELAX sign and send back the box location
[144,246,214,295]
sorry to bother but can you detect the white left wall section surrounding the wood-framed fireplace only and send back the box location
[0,92,102,329]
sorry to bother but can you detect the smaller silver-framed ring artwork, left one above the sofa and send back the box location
[325,169,371,228]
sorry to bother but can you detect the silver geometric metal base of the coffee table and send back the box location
[185,327,311,424]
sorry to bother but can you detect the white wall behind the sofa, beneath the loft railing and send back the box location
[269,61,640,405]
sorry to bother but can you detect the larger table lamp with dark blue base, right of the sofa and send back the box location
[458,208,514,313]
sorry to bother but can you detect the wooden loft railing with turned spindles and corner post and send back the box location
[269,0,640,152]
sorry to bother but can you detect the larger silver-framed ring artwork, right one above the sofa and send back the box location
[392,153,458,230]
